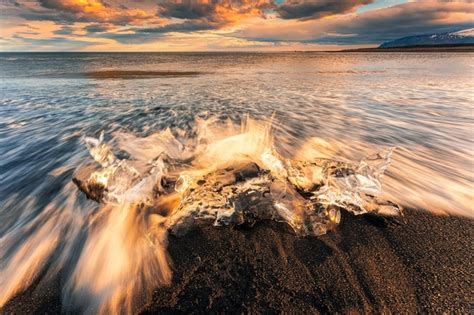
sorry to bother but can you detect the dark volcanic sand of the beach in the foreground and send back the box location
[0,211,474,314]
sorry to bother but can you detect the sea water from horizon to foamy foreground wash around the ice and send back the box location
[0,53,474,312]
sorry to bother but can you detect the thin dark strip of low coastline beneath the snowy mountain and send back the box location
[340,44,474,52]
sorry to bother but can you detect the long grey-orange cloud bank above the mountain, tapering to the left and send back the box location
[236,1,474,44]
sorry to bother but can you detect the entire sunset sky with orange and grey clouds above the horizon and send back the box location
[0,0,474,51]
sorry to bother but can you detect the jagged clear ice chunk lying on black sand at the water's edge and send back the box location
[78,130,401,235]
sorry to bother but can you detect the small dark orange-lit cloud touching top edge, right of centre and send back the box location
[276,0,374,19]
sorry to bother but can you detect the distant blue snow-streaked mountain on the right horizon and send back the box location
[379,28,474,48]
